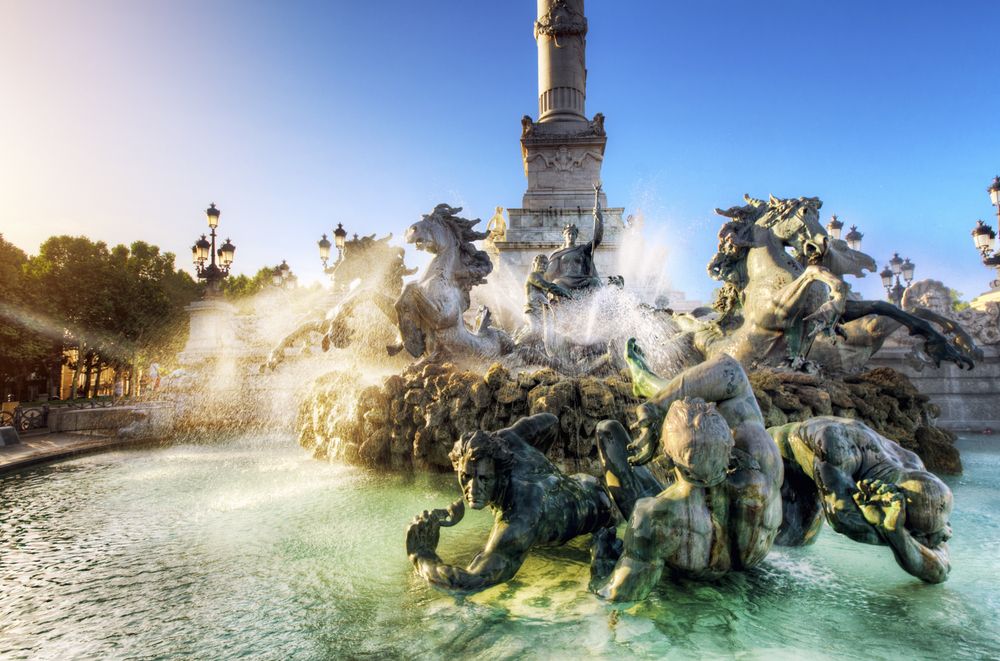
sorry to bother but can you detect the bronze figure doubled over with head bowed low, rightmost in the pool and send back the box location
[768,416,952,583]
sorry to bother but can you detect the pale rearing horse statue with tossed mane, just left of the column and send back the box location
[325,204,513,362]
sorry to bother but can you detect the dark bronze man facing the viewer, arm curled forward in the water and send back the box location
[406,413,614,594]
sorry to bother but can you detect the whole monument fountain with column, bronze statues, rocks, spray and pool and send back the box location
[0,0,1000,658]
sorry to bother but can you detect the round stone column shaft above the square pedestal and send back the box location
[535,0,587,124]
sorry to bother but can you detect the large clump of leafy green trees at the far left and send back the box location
[0,236,202,392]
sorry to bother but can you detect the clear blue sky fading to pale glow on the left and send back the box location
[0,0,1000,299]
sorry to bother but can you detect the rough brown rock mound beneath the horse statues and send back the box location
[297,363,961,475]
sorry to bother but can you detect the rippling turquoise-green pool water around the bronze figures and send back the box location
[0,437,1000,659]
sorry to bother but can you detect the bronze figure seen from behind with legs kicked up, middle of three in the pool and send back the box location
[591,340,783,601]
